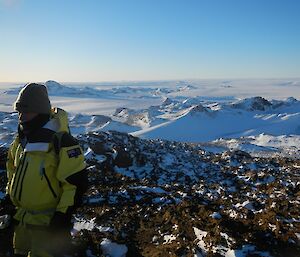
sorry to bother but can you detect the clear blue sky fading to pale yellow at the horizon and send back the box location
[0,0,300,82]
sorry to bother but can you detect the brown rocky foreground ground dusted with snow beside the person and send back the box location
[0,132,300,256]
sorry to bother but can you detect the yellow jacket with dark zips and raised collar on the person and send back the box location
[6,109,86,226]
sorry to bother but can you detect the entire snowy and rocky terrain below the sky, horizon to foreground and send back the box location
[0,79,300,256]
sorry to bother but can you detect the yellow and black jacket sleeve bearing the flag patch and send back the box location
[54,133,87,213]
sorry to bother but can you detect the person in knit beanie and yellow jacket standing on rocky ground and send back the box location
[6,83,87,257]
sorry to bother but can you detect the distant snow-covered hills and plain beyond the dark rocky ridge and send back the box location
[0,80,300,157]
